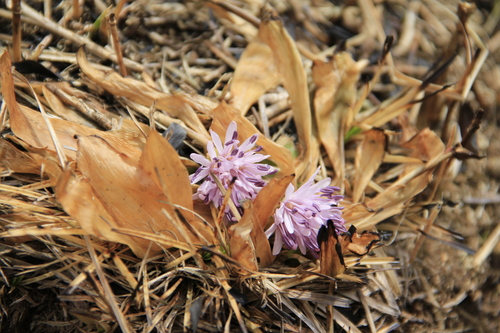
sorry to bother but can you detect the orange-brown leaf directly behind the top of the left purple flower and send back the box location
[211,102,294,176]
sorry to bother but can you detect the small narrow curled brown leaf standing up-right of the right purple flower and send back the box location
[352,128,387,203]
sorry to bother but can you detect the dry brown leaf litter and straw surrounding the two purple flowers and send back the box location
[0,1,500,332]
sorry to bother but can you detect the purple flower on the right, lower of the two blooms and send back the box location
[266,168,347,258]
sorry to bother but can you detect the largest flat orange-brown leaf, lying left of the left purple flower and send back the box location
[64,136,201,256]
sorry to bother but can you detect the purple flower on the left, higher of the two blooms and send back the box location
[190,121,277,221]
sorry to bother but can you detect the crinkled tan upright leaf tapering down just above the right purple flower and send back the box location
[312,52,360,189]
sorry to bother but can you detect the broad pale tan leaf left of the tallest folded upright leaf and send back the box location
[230,35,280,115]
